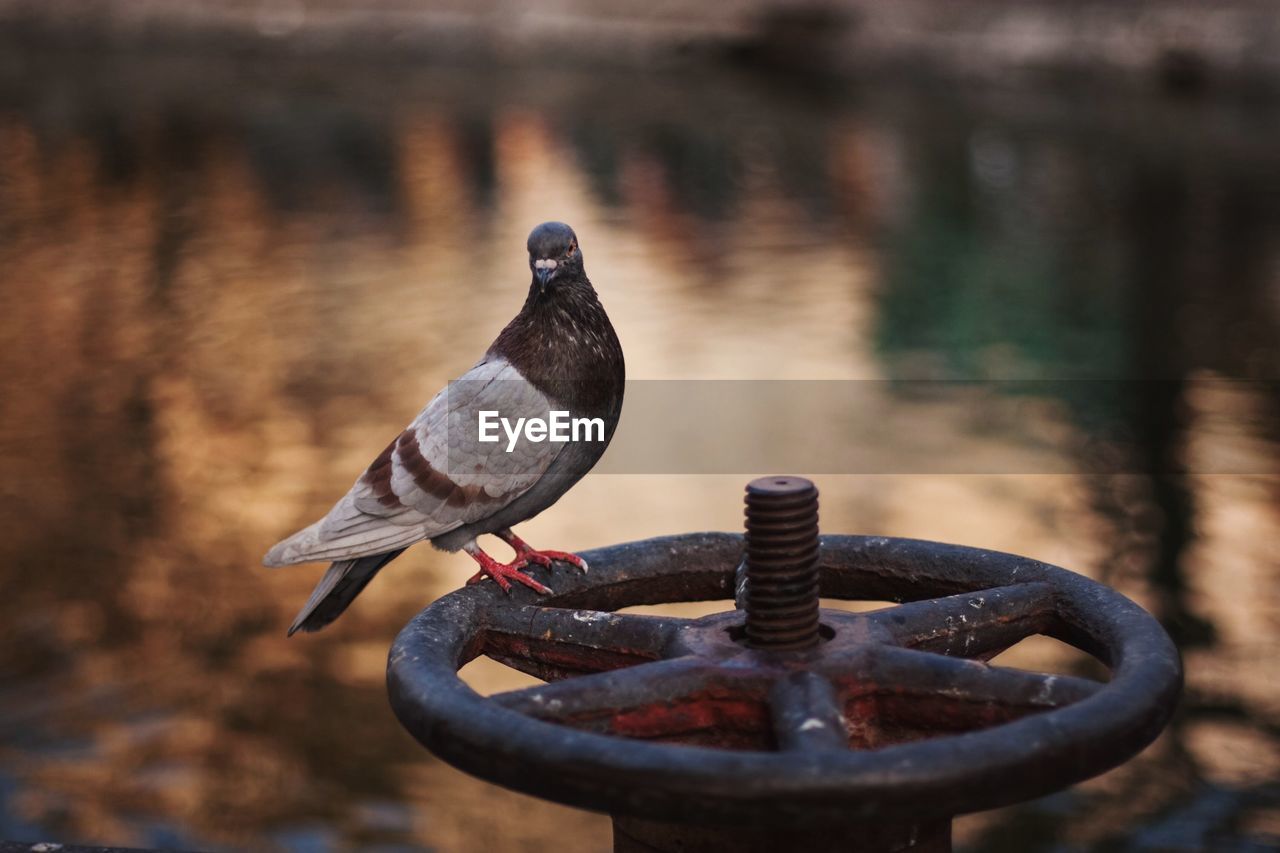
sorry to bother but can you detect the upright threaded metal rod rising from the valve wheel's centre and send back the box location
[746,476,818,651]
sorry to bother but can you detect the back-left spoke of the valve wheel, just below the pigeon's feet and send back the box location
[477,605,690,681]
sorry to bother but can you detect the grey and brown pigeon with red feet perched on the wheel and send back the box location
[262,222,626,637]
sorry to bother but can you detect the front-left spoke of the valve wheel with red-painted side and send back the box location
[490,656,769,740]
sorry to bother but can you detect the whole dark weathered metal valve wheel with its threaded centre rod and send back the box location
[388,478,1181,849]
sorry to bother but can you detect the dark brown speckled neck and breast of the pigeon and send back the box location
[489,277,625,414]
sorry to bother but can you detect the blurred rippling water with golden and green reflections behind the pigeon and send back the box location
[0,50,1280,850]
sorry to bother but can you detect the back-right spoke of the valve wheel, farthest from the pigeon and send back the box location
[867,583,1057,660]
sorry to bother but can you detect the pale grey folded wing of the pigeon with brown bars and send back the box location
[264,357,563,566]
